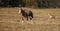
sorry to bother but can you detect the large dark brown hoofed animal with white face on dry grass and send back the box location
[19,8,33,20]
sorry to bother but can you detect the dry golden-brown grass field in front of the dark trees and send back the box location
[0,8,60,31]
